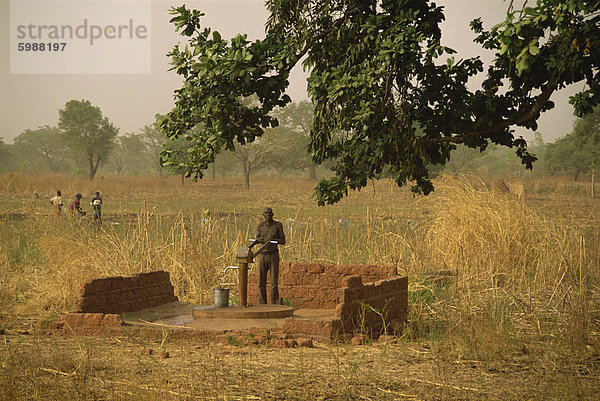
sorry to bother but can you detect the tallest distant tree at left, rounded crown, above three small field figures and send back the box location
[58,100,119,179]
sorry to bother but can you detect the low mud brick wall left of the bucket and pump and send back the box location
[76,270,178,314]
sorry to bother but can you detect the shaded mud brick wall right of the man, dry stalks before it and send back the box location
[335,276,408,333]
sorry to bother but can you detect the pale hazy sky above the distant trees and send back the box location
[0,0,580,143]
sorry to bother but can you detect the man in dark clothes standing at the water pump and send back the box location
[252,207,285,305]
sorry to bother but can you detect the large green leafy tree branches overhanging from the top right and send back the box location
[161,0,600,205]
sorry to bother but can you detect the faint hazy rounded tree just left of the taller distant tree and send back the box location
[14,125,71,173]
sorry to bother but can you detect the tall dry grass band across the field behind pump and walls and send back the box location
[0,171,600,359]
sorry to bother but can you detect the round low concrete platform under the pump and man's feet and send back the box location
[192,305,294,319]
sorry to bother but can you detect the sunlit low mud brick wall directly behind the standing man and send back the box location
[248,262,396,309]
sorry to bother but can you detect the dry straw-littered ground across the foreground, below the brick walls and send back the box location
[0,316,600,400]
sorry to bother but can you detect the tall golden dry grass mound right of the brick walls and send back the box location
[408,176,600,357]
